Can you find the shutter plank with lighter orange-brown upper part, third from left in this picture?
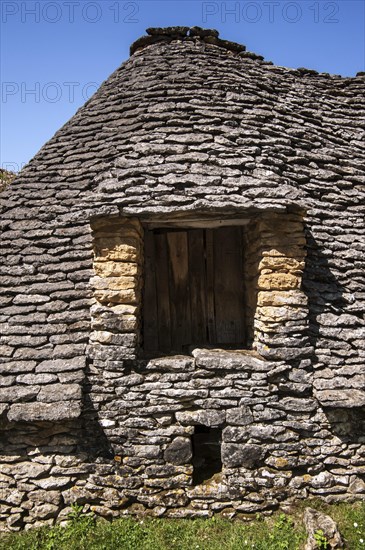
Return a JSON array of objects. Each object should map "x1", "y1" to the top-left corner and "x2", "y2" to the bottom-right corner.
[{"x1": 167, "y1": 231, "x2": 191, "y2": 352}]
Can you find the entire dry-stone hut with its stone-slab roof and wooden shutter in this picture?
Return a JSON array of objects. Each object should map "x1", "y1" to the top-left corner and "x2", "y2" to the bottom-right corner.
[{"x1": 0, "y1": 27, "x2": 365, "y2": 529}]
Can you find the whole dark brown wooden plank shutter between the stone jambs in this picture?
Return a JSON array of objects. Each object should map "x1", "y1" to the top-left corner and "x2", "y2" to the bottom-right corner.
[{"x1": 143, "y1": 226, "x2": 246, "y2": 354}]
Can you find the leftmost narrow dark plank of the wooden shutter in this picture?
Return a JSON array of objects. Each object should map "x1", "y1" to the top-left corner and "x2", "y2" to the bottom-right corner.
[{"x1": 143, "y1": 231, "x2": 158, "y2": 352}]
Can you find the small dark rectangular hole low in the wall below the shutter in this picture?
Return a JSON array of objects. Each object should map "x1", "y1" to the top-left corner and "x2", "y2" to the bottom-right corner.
[{"x1": 191, "y1": 425, "x2": 222, "y2": 485}]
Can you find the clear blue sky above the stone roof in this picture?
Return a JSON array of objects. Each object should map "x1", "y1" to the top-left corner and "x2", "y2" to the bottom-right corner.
[{"x1": 0, "y1": 0, "x2": 365, "y2": 171}]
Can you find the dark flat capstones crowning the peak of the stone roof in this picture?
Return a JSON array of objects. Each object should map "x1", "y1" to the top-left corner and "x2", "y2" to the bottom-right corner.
[{"x1": 130, "y1": 27, "x2": 250, "y2": 59}]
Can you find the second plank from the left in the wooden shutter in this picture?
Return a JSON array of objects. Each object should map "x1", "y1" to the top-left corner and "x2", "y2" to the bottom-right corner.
[{"x1": 155, "y1": 232, "x2": 171, "y2": 352}]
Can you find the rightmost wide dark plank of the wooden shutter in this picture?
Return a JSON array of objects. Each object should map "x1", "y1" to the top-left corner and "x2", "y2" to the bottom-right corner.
[{"x1": 214, "y1": 227, "x2": 244, "y2": 344}]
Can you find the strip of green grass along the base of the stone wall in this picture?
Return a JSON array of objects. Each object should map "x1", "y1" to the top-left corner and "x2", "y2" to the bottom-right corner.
[{"x1": 0, "y1": 501, "x2": 365, "y2": 550}]
